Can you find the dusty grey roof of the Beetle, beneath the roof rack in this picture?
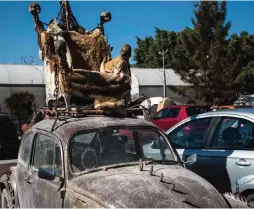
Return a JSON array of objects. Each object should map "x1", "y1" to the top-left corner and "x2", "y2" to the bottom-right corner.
[{"x1": 32, "y1": 116, "x2": 159, "y2": 143}]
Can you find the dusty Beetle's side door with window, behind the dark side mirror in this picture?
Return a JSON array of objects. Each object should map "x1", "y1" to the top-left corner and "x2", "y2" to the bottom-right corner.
[{"x1": 26, "y1": 131, "x2": 64, "y2": 208}]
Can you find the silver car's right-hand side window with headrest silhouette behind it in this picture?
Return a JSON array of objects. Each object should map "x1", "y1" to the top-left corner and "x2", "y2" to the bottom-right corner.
[{"x1": 210, "y1": 117, "x2": 254, "y2": 149}]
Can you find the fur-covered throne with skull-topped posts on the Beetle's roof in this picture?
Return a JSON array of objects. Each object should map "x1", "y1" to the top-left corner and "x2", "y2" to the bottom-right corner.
[{"x1": 29, "y1": 1, "x2": 131, "y2": 110}]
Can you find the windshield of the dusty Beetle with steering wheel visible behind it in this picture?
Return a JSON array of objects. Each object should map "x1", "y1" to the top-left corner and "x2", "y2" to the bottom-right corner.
[{"x1": 69, "y1": 127, "x2": 177, "y2": 174}]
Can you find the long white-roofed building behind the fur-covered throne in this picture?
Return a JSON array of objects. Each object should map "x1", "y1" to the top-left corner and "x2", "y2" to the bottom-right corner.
[{"x1": 0, "y1": 64, "x2": 194, "y2": 112}]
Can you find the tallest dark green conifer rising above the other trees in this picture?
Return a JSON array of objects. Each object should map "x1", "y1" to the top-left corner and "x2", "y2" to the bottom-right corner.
[{"x1": 172, "y1": 1, "x2": 234, "y2": 104}]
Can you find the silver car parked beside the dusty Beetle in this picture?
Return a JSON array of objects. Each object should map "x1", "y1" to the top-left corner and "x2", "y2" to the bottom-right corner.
[{"x1": 166, "y1": 108, "x2": 254, "y2": 207}]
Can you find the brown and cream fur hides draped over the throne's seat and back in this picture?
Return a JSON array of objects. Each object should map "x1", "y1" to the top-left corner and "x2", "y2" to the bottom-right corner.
[{"x1": 33, "y1": 14, "x2": 131, "y2": 109}]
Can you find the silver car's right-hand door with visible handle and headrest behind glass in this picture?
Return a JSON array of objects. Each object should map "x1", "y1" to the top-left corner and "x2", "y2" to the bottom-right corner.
[{"x1": 200, "y1": 116, "x2": 254, "y2": 193}]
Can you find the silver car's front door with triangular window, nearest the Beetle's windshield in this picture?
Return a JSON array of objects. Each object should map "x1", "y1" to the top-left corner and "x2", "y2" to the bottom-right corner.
[{"x1": 168, "y1": 116, "x2": 215, "y2": 175}]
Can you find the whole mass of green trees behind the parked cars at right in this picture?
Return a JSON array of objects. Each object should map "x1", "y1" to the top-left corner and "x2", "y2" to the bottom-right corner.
[{"x1": 134, "y1": 1, "x2": 254, "y2": 104}]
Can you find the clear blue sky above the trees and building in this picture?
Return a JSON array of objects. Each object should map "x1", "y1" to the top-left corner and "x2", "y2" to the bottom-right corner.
[{"x1": 0, "y1": 1, "x2": 254, "y2": 64}]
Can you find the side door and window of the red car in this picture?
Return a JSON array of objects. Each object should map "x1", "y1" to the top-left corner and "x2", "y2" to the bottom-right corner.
[{"x1": 153, "y1": 107, "x2": 180, "y2": 131}]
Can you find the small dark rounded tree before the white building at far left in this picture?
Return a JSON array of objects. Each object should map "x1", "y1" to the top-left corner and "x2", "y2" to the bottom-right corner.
[{"x1": 4, "y1": 91, "x2": 35, "y2": 127}]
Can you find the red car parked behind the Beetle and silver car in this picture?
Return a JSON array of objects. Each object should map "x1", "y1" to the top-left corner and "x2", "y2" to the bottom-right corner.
[{"x1": 152, "y1": 105, "x2": 211, "y2": 131}]
